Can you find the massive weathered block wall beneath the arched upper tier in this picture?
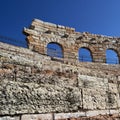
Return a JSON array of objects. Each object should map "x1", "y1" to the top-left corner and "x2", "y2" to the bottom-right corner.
[{"x1": 0, "y1": 43, "x2": 120, "y2": 120}]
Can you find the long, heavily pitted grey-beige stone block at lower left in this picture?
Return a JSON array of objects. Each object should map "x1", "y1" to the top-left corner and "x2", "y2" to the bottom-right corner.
[{"x1": 0, "y1": 80, "x2": 81, "y2": 115}]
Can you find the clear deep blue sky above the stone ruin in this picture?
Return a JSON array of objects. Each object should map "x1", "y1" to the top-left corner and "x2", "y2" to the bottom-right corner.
[{"x1": 0, "y1": 0, "x2": 120, "y2": 40}]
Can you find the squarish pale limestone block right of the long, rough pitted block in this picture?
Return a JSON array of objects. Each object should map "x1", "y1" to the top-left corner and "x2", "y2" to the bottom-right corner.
[{"x1": 82, "y1": 88, "x2": 106, "y2": 110}]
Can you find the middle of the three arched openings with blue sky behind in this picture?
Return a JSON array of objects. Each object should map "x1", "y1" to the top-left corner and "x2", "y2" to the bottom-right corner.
[{"x1": 78, "y1": 47, "x2": 93, "y2": 62}]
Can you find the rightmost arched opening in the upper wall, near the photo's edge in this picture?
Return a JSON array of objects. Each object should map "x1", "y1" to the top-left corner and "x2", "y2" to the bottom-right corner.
[{"x1": 106, "y1": 49, "x2": 119, "y2": 64}]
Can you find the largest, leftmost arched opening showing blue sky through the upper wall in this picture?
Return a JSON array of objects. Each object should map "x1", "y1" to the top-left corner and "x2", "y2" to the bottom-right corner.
[{"x1": 47, "y1": 42, "x2": 63, "y2": 58}]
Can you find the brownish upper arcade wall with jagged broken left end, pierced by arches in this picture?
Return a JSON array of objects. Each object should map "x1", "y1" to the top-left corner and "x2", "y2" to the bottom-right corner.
[{"x1": 24, "y1": 19, "x2": 120, "y2": 63}]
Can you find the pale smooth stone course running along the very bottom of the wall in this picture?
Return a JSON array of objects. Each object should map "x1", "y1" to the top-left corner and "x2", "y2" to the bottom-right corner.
[{"x1": 0, "y1": 110, "x2": 120, "y2": 120}]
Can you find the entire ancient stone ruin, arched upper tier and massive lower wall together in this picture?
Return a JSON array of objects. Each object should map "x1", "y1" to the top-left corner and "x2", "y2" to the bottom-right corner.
[{"x1": 0, "y1": 19, "x2": 120, "y2": 120}]
